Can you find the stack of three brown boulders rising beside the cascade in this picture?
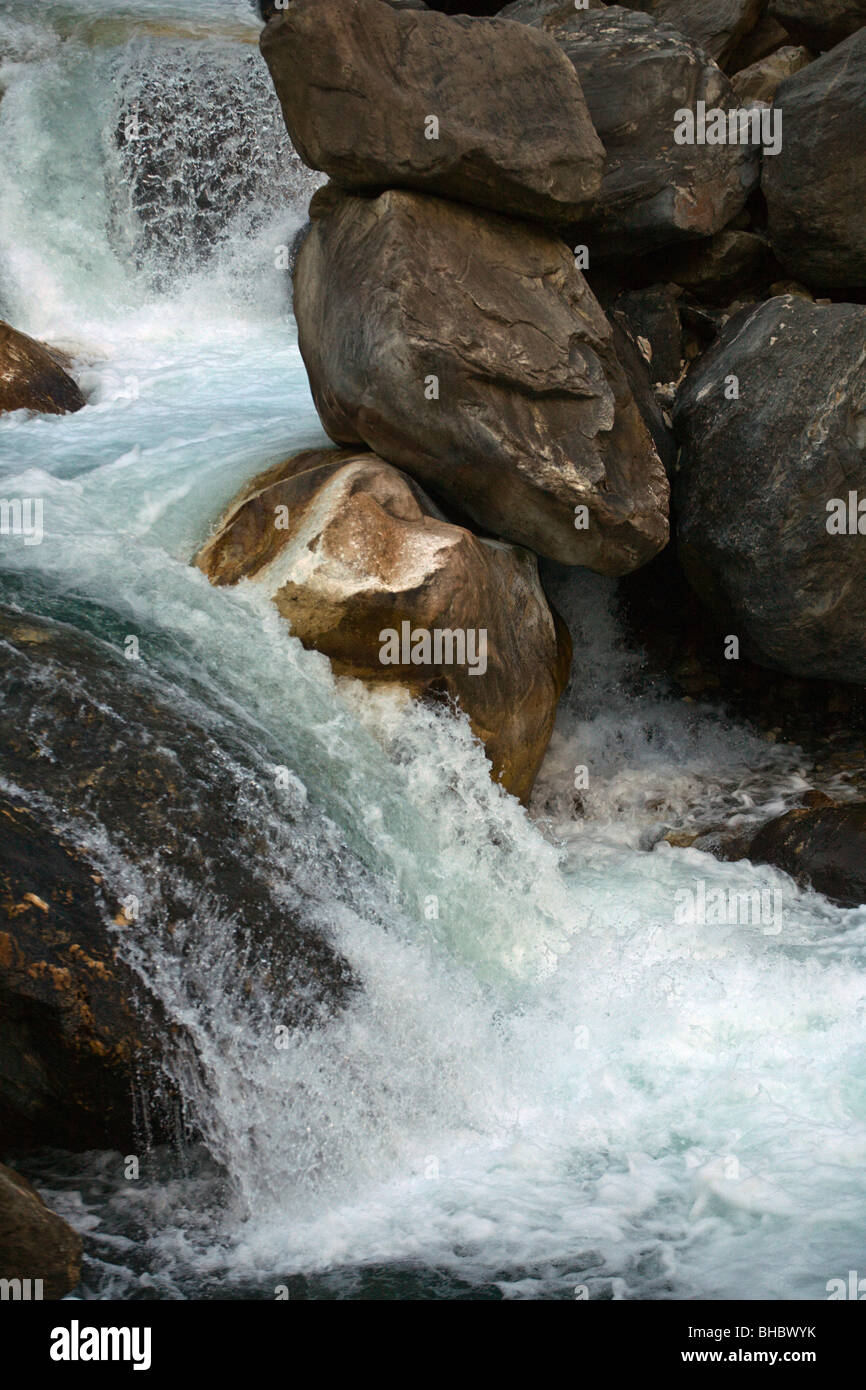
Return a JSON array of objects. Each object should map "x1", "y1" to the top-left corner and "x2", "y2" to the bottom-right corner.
[{"x1": 199, "y1": 0, "x2": 675, "y2": 799}]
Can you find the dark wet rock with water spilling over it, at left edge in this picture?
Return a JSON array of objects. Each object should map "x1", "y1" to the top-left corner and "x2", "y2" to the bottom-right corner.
[{"x1": 0, "y1": 609, "x2": 352, "y2": 1152}]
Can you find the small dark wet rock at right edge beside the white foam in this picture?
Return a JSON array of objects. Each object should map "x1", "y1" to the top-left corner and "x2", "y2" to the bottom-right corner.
[{"x1": 724, "y1": 802, "x2": 866, "y2": 908}]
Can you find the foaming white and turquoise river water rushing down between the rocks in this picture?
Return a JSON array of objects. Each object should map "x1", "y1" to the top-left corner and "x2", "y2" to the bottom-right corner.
[{"x1": 0, "y1": 0, "x2": 866, "y2": 1300}]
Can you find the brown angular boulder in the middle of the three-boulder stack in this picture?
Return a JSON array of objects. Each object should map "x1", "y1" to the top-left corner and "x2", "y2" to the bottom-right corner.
[{"x1": 295, "y1": 189, "x2": 667, "y2": 574}]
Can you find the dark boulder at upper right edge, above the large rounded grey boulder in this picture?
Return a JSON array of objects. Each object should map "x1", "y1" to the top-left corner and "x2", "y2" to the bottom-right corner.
[{"x1": 762, "y1": 29, "x2": 866, "y2": 288}]
